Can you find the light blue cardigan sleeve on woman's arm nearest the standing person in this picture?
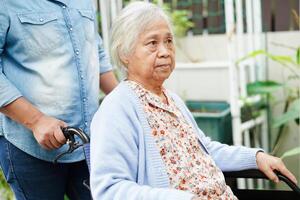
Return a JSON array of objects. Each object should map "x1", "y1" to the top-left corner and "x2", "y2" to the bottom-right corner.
[{"x1": 90, "y1": 86, "x2": 193, "y2": 200}]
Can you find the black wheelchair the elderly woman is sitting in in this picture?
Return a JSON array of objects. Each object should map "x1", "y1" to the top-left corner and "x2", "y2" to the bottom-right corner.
[{"x1": 54, "y1": 127, "x2": 300, "y2": 200}]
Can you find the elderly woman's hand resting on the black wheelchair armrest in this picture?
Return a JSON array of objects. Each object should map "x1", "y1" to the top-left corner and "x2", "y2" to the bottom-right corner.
[{"x1": 256, "y1": 152, "x2": 297, "y2": 184}]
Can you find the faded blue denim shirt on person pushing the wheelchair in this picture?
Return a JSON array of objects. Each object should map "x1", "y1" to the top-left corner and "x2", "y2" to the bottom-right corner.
[{"x1": 0, "y1": 0, "x2": 112, "y2": 162}]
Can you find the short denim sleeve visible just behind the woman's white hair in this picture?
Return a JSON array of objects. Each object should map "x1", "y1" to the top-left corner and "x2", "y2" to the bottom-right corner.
[{"x1": 97, "y1": 34, "x2": 112, "y2": 74}]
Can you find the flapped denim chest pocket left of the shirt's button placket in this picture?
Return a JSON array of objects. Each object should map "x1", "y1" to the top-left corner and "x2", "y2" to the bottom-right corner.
[{"x1": 18, "y1": 13, "x2": 63, "y2": 55}]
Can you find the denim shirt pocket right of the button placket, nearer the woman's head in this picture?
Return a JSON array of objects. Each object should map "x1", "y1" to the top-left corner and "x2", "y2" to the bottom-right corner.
[{"x1": 78, "y1": 10, "x2": 96, "y2": 42}]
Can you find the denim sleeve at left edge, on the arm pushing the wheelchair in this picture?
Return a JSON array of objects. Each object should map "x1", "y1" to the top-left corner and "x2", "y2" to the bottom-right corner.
[{"x1": 0, "y1": 0, "x2": 22, "y2": 107}]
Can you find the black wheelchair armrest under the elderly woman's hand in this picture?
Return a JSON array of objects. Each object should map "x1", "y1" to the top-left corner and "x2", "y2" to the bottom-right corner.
[{"x1": 223, "y1": 169, "x2": 300, "y2": 195}]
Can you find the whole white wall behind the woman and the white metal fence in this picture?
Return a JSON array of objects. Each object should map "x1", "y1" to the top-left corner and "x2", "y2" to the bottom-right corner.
[{"x1": 166, "y1": 31, "x2": 300, "y2": 101}]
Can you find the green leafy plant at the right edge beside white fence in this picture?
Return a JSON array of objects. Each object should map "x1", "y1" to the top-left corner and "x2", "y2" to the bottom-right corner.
[{"x1": 237, "y1": 44, "x2": 300, "y2": 158}]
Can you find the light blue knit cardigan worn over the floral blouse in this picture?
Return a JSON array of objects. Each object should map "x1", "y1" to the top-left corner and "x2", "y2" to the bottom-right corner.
[{"x1": 90, "y1": 82, "x2": 258, "y2": 200}]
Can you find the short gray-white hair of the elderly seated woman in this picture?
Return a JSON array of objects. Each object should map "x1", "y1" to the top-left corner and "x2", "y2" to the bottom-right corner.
[{"x1": 110, "y1": 2, "x2": 173, "y2": 68}]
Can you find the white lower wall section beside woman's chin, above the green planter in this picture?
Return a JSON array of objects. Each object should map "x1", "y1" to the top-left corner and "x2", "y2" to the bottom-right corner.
[{"x1": 166, "y1": 62, "x2": 229, "y2": 101}]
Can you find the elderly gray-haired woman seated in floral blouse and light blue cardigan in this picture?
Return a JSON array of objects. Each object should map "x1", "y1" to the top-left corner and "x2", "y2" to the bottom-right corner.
[{"x1": 91, "y1": 2, "x2": 296, "y2": 200}]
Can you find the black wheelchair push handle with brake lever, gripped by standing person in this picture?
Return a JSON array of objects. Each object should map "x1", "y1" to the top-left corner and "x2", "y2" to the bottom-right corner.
[{"x1": 53, "y1": 127, "x2": 90, "y2": 163}]
